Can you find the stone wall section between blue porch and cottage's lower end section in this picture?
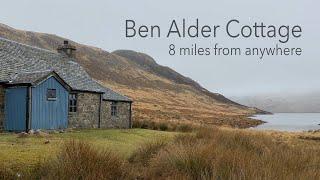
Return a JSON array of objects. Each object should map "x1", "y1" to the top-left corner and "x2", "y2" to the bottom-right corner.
[{"x1": 68, "y1": 92, "x2": 100, "y2": 128}]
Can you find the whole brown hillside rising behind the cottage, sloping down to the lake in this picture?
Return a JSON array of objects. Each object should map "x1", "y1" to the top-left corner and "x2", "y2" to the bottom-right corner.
[{"x1": 0, "y1": 24, "x2": 260, "y2": 127}]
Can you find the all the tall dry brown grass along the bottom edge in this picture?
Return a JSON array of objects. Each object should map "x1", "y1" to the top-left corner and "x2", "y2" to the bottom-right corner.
[{"x1": 0, "y1": 128, "x2": 320, "y2": 180}]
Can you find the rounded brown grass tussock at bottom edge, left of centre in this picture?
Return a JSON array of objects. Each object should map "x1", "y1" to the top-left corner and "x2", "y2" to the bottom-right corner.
[{"x1": 40, "y1": 141, "x2": 125, "y2": 179}]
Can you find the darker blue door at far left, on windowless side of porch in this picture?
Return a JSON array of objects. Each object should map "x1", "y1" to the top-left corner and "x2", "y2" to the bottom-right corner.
[{"x1": 5, "y1": 87, "x2": 27, "y2": 131}]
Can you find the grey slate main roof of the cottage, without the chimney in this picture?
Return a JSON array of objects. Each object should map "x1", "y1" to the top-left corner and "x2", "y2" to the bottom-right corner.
[{"x1": 0, "y1": 37, "x2": 131, "y2": 102}]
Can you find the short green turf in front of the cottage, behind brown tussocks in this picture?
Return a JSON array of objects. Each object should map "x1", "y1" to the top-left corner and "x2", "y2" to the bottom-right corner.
[{"x1": 0, "y1": 129, "x2": 175, "y2": 172}]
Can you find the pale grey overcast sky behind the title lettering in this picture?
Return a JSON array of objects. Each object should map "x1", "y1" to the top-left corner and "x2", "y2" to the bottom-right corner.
[{"x1": 0, "y1": 0, "x2": 320, "y2": 96}]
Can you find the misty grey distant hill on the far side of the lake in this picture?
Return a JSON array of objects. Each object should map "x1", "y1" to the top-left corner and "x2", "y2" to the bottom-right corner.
[{"x1": 231, "y1": 92, "x2": 320, "y2": 113}]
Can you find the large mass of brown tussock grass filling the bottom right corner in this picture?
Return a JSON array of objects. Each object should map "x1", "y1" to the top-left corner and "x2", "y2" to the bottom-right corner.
[{"x1": 138, "y1": 129, "x2": 320, "y2": 179}]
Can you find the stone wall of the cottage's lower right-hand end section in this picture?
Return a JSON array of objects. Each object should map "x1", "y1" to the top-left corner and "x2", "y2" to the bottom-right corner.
[{"x1": 101, "y1": 101, "x2": 131, "y2": 128}]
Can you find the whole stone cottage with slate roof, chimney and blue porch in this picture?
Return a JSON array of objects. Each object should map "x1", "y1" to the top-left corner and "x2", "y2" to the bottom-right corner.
[{"x1": 0, "y1": 38, "x2": 132, "y2": 131}]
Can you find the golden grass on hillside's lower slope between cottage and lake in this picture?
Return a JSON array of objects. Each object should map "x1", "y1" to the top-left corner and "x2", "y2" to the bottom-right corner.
[{"x1": 107, "y1": 85, "x2": 262, "y2": 128}]
